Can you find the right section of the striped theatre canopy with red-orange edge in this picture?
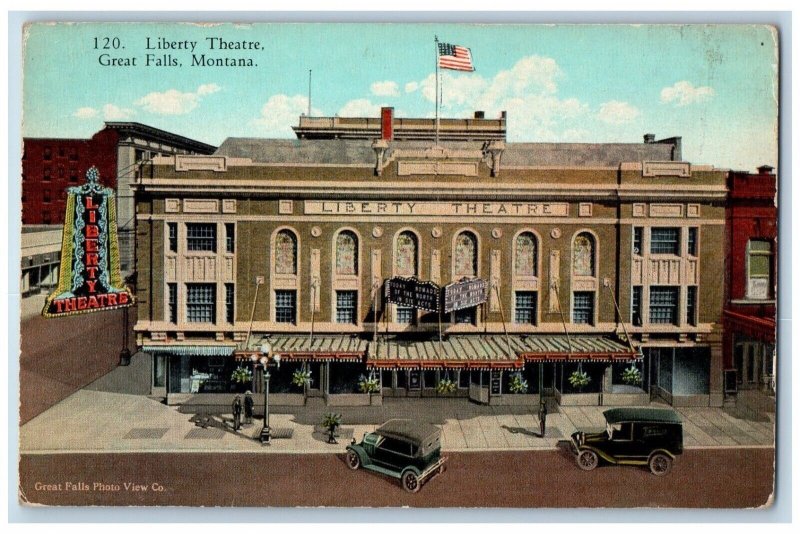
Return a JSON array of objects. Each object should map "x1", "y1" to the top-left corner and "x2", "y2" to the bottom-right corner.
[{"x1": 511, "y1": 335, "x2": 640, "y2": 362}]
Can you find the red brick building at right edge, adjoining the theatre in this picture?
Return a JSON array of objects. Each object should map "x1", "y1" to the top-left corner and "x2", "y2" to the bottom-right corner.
[{"x1": 724, "y1": 165, "x2": 778, "y2": 393}]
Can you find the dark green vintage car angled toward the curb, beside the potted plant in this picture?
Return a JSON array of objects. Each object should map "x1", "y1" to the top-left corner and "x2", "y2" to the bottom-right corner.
[{"x1": 347, "y1": 419, "x2": 447, "y2": 493}]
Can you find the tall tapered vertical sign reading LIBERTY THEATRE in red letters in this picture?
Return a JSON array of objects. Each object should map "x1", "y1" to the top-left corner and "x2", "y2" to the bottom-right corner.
[{"x1": 42, "y1": 167, "x2": 134, "y2": 317}]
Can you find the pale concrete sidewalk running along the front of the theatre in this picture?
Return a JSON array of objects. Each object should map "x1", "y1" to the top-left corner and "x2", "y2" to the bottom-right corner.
[{"x1": 20, "y1": 355, "x2": 775, "y2": 454}]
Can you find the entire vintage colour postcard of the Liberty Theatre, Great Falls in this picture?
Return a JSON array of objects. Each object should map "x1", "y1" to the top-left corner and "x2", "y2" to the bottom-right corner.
[{"x1": 17, "y1": 22, "x2": 781, "y2": 509}]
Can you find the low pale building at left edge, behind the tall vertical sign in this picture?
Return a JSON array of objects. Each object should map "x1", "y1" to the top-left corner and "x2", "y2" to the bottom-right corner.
[{"x1": 19, "y1": 225, "x2": 62, "y2": 319}]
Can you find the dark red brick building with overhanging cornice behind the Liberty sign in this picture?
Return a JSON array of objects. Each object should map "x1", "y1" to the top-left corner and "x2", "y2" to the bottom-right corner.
[{"x1": 22, "y1": 122, "x2": 215, "y2": 273}]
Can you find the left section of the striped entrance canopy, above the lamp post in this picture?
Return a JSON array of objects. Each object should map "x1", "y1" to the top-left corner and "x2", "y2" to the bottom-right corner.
[{"x1": 234, "y1": 334, "x2": 369, "y2": 362}]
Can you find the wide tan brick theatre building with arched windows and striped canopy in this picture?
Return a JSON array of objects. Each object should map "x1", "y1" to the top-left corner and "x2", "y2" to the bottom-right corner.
[{"x1": 134, "y1": 114, "x2": 726, "y2": 406}]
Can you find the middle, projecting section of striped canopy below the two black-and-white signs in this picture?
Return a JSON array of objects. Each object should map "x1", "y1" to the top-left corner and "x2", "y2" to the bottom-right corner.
[{"x1": 367, "y1": 335, "x2": 524, "y2": 369}]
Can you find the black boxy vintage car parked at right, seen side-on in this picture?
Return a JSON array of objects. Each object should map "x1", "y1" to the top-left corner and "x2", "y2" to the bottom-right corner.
[{"x1": 572, "y1": 408, "x2": 683, "y2": 476}]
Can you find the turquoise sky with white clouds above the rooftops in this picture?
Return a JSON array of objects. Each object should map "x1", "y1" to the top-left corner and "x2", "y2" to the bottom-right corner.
[{"x1": 23, "y1": 23, "x2": 778, "y2": 171}]
